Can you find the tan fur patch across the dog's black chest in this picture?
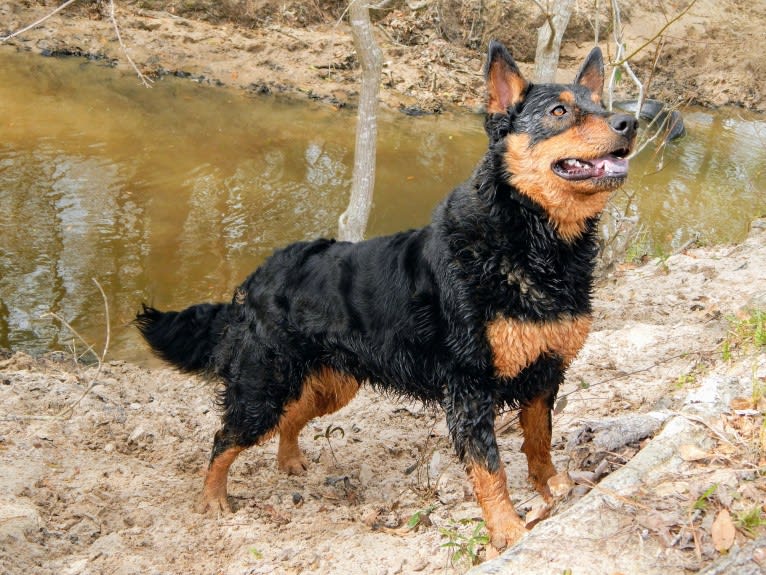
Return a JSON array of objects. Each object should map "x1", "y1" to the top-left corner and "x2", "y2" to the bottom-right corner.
[{"x1": 487, "y1": 316, "x2": 592, "y2": 377}]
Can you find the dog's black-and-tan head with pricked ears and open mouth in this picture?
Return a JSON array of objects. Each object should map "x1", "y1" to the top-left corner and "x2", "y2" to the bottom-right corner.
[{"x1": 485, "y1": 41, "x2": 638, "y2": 240}]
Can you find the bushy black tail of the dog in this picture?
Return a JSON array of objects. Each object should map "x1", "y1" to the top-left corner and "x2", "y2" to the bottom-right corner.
[{"x1": 133, "y1": 303, "x2": 231, "y2": 373}]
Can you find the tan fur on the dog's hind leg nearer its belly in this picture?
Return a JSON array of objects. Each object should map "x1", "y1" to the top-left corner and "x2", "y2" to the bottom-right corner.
[{"x1": 277, "y1": 367, "x2": 359, "y2": 475}]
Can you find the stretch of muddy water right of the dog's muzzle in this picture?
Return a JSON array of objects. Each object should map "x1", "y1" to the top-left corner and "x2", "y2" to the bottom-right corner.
[{"x1": 627, "y1": 111, "x2": 766, "y2": 253}]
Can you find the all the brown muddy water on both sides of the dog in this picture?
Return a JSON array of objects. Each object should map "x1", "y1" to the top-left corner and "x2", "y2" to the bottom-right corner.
[{"x1": 0, "y1": 50, "x2": 766, "y2": 361}]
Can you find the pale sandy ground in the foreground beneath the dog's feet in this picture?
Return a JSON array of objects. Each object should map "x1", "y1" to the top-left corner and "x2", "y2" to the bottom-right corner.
[{"x1": 0, "y1": 220, "x2": 766, "y2": 574}]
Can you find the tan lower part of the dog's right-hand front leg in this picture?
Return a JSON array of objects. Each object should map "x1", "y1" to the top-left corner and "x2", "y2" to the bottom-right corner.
[{"x1": 519, "y1": 397, "x2": 556, "y2": 501}]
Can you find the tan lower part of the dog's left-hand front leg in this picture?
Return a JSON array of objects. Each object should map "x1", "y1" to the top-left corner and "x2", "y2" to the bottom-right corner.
[{"x1": 468, "y1": 464, "x2": 526, "y2": 550}]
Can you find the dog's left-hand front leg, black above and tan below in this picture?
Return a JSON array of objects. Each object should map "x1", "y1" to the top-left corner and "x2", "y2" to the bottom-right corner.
[{"x1": 445, "y1": 385, "x2": 526, "y2": 551}]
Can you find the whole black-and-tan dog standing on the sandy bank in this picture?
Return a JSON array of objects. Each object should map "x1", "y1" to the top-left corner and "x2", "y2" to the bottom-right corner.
[{"x1": 135, "y1": 41, "x2": 638, "y2": 550}]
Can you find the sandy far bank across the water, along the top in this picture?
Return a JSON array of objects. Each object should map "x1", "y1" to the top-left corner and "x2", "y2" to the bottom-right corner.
[{"x1": 0, "y1": 0, "x2": 766, "y2": 112}]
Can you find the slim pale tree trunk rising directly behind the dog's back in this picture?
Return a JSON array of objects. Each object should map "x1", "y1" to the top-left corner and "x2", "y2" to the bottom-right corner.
[{"x1": 338, "y1": 0, "x2": 383, "y2": 242}]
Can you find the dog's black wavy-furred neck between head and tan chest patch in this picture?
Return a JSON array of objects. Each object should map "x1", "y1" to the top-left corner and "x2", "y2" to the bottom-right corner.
[{"x1": 432, "y1": 158, "x2": 598, "y2": 319}]
